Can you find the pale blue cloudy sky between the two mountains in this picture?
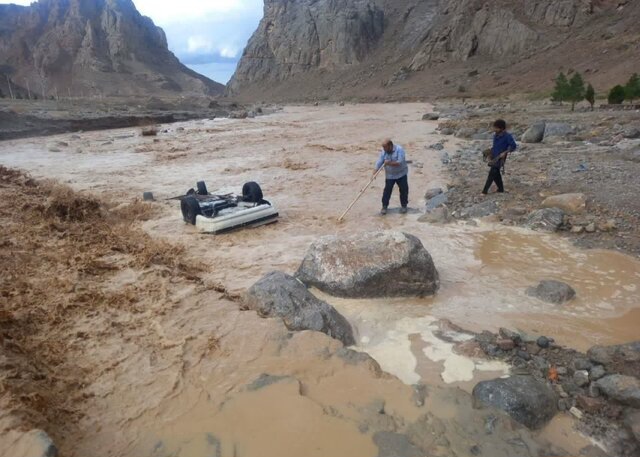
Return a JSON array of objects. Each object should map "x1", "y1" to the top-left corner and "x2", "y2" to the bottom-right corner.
[{"x1": 0, "y1": 0, "x2": 263, "y2": 83}]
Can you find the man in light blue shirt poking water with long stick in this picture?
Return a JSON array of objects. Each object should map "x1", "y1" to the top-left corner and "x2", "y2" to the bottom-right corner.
[{"x1": 374, "y1": 140, "x2": 409, "y2": 216}]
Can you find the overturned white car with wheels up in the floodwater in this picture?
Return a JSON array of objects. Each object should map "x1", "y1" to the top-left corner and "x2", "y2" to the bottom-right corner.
[{"x1": 180, "y1": 181, "x2": 279, "y2": 234}]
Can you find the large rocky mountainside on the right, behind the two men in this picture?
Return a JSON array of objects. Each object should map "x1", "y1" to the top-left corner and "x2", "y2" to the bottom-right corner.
[{"x1": 228, "y1": 0, "x2": 640, "y2": 97}]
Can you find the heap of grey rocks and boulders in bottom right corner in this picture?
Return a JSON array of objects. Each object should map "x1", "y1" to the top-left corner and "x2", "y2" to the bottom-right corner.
[{"x1": 450, "y1": 324, "x2": 640, "y2": 457}]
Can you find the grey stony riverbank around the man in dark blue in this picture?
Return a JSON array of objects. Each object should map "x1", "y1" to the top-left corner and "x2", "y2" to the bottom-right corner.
[{"x1": 425, "y1": 102, "x2": 640, "y2": 255}]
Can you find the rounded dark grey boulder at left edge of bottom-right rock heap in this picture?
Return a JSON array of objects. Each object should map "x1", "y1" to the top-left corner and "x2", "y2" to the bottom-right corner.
[{"x1": 473, "y1": 376, "x2": 558, "y2": 429}]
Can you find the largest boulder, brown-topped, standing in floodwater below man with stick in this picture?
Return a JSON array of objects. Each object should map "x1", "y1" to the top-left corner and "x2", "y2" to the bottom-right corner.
[{"x1": 297, "y1": 231, "x2": 440, "y2": 298}]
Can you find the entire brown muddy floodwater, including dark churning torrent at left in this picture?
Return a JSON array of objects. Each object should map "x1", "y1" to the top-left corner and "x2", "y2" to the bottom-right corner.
[{"x1": 0, "y1": 104, "x2": 640, "y2": 456}]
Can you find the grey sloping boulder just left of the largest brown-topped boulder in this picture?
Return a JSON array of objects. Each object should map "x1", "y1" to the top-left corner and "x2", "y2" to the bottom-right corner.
[{"x1": 244, "y1": 271, "x2": 355, "y2": 346}]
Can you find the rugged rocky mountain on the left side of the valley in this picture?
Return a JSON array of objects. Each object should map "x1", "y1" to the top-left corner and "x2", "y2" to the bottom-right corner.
[{"x1": 0, "y1": 0, "x2": 223, "y2": 96}]
